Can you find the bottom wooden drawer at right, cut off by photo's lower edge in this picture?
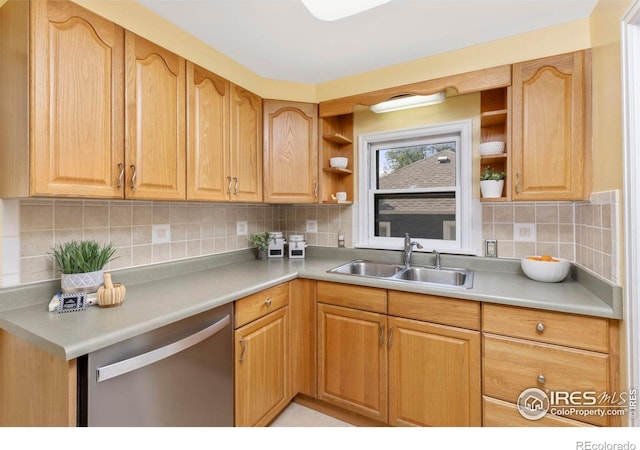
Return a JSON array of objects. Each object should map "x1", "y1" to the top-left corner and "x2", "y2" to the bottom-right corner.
[{"x1": 482, "y1": 397, "x2": 591, "y2": 427}]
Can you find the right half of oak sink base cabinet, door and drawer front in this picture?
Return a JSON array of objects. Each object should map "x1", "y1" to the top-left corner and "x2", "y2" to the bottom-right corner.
[{"x1": 387, "y1": 290, "x2": 482, "y2": 427}]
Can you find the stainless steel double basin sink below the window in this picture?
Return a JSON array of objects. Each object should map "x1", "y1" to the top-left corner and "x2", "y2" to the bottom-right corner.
[{"x1": 328, "y1": 259, "x2": 473, "y2": 289}]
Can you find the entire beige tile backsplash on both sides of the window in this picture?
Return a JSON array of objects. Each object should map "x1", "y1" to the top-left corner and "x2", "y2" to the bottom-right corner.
[{"x1": 0, "y1": 191, "x2": 621, "y2": 287}]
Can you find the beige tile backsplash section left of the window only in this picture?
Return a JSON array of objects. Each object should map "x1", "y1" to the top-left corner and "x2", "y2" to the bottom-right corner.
[{"x1": 11, "y1": 199, "x2": 351, "y2": 287}]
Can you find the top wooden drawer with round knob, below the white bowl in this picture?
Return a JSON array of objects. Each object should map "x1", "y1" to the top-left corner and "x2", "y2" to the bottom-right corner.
[{"x1": 482, "y1": 304, "x2": 609, "y2": 353}]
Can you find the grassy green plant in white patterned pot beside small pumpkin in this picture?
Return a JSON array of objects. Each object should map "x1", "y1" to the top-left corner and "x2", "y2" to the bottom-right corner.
[{"x1": 51, "y1": 241, "x2": 116, "y2": 293}]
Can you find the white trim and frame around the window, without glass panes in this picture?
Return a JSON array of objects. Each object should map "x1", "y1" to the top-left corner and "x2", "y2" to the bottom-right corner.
[{"x1": 355, "y1": 119, "x2": 482, "y2": 255}]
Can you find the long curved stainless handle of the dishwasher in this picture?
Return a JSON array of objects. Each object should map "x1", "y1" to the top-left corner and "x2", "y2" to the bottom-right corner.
[{"x1": 96, "y1": 314, "x2": 231, "y2": 383}]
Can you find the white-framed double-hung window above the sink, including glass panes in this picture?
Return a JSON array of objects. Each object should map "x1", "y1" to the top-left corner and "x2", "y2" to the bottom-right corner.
[{"x1": 358, "y1": 120, "x2": 480, "y2": 254}]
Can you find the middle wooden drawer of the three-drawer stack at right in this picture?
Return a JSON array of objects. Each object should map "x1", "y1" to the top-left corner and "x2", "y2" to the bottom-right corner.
[{"x1": 482, "y1": 335, "x2": 610, "y2": 425}]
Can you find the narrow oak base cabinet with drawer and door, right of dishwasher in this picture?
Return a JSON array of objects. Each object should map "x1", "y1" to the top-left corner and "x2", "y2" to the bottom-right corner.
[{"x1": 234, "y1": 283, "x2": 292, "y2": 427}]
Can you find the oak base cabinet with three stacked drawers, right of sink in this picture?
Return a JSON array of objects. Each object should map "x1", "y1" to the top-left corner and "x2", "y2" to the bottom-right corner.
[{"x1": 482, "y1": 304, "x2": 620, "y2": 426}]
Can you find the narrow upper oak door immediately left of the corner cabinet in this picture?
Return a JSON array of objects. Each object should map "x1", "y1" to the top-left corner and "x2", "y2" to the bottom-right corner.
[{"x1": 229, "y1": 84, "x2": 262, "y2": 202}]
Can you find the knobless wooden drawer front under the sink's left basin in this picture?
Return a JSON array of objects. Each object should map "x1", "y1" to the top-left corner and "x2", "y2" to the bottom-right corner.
[{"x1": 318, "y1": 281, "x2": 387, "y2": 314}]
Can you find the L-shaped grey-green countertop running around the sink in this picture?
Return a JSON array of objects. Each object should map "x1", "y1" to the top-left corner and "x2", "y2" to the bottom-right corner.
[{"x1": 0, "y1": 248, "x2": 622, "y2": 360}]
